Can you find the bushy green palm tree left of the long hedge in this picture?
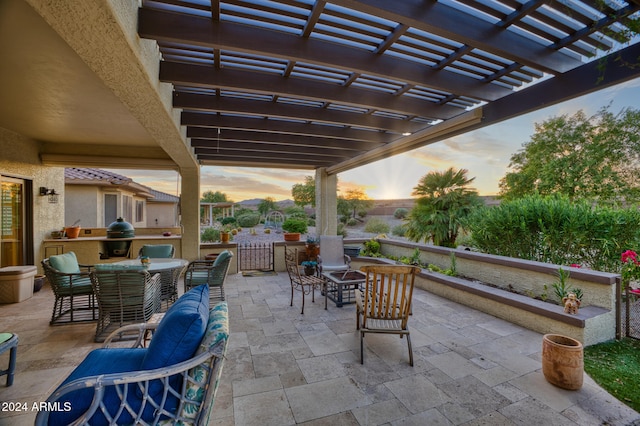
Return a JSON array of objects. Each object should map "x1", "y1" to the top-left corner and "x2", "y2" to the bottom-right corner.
[{"x1": 405, "y1": 168, "x2": 482, "y2": 247}]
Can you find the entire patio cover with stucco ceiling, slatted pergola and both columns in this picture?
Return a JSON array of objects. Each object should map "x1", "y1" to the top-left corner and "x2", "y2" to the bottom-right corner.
[{"x1": 0, "y1": 0, "x2": 640, "y2": 256}]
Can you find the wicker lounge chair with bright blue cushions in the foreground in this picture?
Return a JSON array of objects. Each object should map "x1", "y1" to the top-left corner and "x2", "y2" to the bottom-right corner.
[{"x1": 35, "y1": 286, "x2": 229, "y2": 426}]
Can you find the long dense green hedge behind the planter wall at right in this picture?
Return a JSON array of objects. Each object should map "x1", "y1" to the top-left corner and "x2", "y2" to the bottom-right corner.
[{"x1": 467, "y1": 196, "x2": 640, "y2": 273}]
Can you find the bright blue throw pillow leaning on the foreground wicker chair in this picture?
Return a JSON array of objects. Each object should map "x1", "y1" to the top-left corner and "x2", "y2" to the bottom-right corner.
[{"x1": 142, "y1": 284, "x2": 209, "y2": 370}]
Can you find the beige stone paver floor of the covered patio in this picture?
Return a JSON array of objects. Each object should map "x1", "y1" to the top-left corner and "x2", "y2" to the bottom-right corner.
[{"x1": 0, "y1": 274, "x2": 640, "y2": 426}]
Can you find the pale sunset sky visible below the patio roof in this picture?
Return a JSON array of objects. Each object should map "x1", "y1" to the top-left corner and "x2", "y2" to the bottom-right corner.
[{"x1": 110, "y1": 79, "x2": 640, "y2": 202}]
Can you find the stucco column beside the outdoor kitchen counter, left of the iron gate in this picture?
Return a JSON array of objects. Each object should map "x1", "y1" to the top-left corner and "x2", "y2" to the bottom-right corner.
[{"x1": 180, "y1": 168, "x2": 200, "y2": 260}]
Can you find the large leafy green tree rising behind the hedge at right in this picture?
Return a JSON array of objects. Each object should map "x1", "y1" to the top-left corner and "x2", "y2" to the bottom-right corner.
[{"x1": 500, "y1": 107, "x2": 640, "y2": 203}]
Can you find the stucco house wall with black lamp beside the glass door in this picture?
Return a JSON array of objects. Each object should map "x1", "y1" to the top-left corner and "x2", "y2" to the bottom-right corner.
[{"x1": 0, "y1": 128, "x2": 64, "y2": 266}]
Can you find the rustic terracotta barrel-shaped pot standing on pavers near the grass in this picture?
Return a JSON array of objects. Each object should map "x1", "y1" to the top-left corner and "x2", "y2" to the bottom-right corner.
[{"x1": 542, "y1": 334, "x2": 584, "y2": 390}]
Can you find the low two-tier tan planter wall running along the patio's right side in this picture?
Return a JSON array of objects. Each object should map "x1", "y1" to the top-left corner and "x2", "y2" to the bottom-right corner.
[{"x1": 362, "y1": 239, "x2": 619, "y2": 346}]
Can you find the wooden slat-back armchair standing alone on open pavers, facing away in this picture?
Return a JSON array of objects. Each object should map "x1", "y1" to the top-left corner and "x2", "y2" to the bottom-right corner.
[{"x1": 356, "y1": 265, "x2": 420, "y2": 366}]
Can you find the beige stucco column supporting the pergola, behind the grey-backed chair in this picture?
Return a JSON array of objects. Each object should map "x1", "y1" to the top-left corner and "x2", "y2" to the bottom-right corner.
[{"x1": 316, "y1": 168, "x2": 338, "y2": 235}]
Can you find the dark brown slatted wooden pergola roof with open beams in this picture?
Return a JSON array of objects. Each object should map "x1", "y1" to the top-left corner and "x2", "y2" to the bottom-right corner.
[{"x1": 138, "y1": 0, "x2": 640, "y2": 173}]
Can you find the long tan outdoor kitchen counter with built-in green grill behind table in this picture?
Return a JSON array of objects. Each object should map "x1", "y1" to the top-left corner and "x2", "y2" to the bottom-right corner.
[{"x1": 41, "y1": 234, "x2": 182, "y2": 265}]
